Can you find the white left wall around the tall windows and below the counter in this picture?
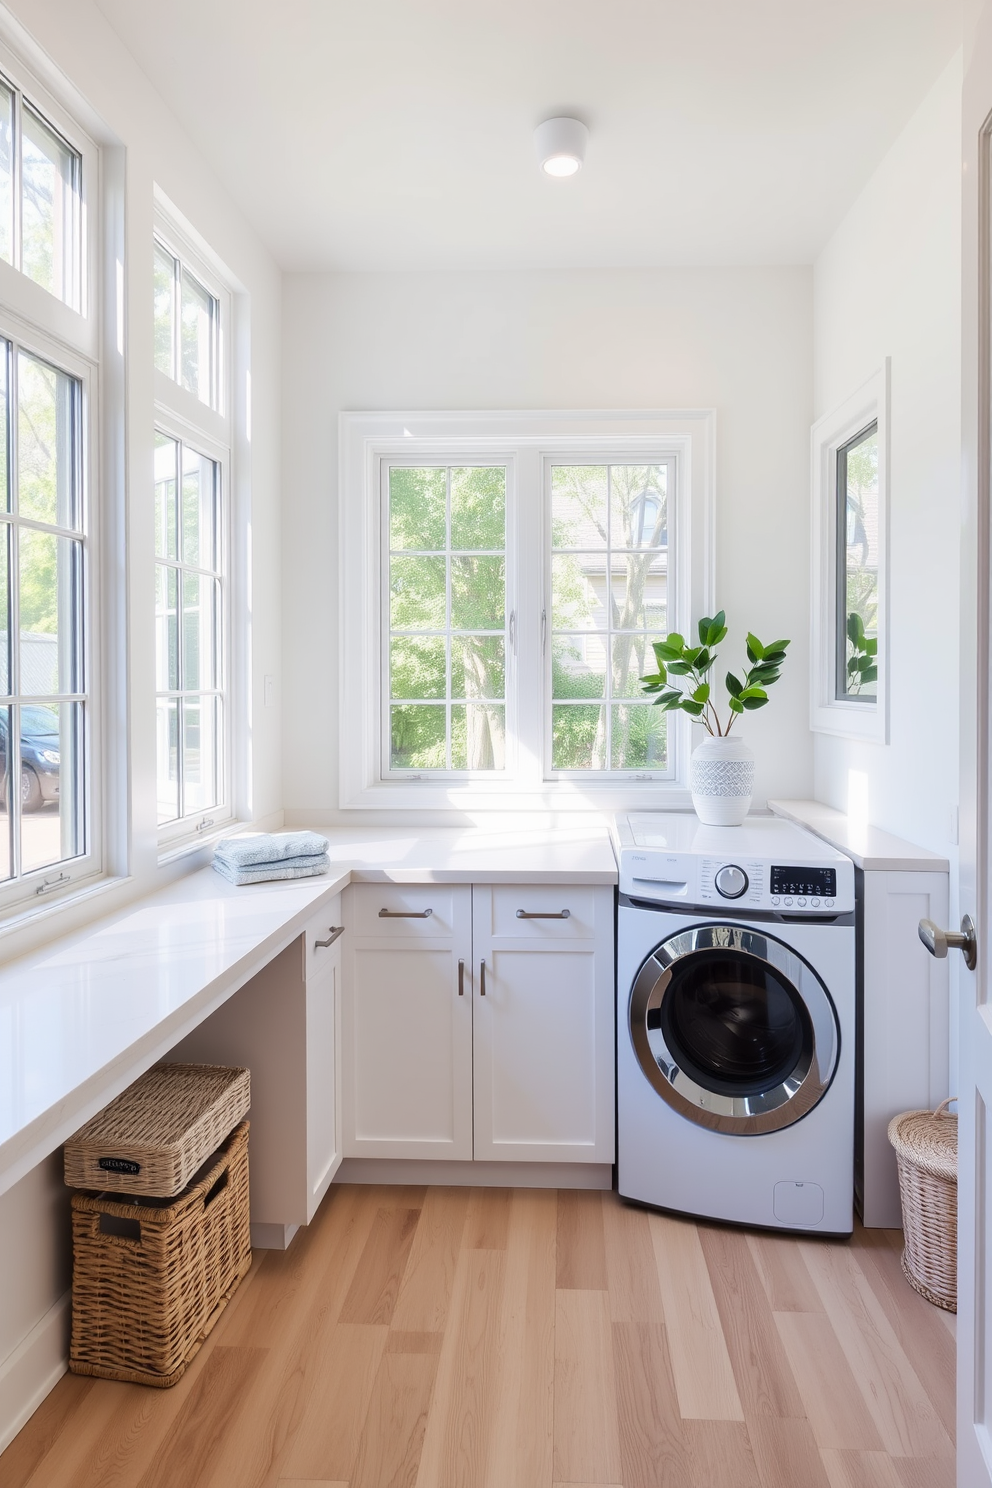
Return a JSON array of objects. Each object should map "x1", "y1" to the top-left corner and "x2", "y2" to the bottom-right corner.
[{"x1": 0, "y1": 0, "x2": 281, "y2": 1446}]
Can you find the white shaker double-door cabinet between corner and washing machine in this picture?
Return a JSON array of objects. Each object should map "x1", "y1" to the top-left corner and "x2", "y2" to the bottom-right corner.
[{"x1": 344, "y1": 884, "x2": 614, "y2": 1164}]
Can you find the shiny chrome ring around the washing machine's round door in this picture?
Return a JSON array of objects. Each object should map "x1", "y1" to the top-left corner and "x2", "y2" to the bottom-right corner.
[{"x1": 628, "y1": 924, "x2": 840, "y2": 1137}]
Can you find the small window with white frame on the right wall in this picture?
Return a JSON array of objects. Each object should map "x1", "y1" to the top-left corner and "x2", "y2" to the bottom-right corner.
[{"x1": 811, "y1": 365, "x2": 888, "y2": 743}]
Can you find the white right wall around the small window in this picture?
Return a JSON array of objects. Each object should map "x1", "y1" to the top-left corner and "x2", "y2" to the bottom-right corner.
[{"x1": 814, "y1": 57, "x2": 961, "y2": 857}]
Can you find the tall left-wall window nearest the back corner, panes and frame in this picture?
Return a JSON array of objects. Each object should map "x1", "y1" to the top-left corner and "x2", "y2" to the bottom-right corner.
[{"x1": 153, "y1": 222, "x2": 233, "y2": 850}]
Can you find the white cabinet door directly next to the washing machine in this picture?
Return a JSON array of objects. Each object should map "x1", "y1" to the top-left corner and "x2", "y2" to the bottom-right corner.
[{"x1": 473, "y1": 885, "x2": 614, "y2": 1162}]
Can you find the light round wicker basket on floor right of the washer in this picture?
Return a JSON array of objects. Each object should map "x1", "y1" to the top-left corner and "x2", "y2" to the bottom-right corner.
[{"x1": 889, "y1": 1097, "x2": 958, "y2": 1312}]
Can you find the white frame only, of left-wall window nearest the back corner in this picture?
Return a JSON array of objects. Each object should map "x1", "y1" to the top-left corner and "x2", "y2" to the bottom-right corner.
[{"x1": 147, "y1": 200, "x2": 237, "y2": 862}]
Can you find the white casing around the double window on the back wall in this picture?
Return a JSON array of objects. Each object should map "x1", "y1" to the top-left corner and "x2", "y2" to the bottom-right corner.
[{"x1": 339, "y1": 409, "x2": 715, "y2": 811}]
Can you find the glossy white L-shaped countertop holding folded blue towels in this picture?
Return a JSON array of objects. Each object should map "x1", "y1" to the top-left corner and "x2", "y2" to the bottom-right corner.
[{"x1": 0, "y1": 824, "x2": 617, "y2": 1193}]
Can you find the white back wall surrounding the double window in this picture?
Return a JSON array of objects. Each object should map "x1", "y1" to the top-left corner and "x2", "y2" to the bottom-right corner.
[{"x1": 283, "y1": 268, "x2": 812, "y2": 824}]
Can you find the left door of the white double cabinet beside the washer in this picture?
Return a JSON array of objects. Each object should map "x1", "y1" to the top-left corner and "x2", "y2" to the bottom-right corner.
[{"x1": 342, "y1": 884, "x2": 471, "y2": 1159}]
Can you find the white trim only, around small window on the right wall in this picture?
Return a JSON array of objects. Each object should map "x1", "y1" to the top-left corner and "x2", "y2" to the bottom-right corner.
[{"x1": 809, "y1": 357, "x2": 889, "y2": 744}]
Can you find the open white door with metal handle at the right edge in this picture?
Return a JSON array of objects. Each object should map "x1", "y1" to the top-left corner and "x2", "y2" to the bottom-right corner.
[{"x1": 950, "y1": 17, "x2": 992, "y2": 1488}]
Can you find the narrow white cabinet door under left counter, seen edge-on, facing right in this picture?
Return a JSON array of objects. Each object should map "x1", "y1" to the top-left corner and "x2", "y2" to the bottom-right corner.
[{"x1": 306, "y1": 897, "x2": 342, "y2": 1220}]
